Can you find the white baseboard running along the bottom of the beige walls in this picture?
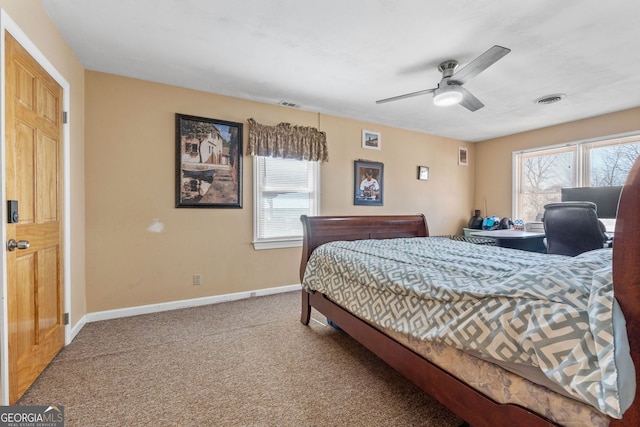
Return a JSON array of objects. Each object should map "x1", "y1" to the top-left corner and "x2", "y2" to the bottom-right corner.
[{"x1": 67, "y1": 284, "x2": 301, "y2": 344}]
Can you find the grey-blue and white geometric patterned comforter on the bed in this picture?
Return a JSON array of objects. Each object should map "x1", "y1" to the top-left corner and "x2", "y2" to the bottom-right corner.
[{"x1": 302, "y1": 237, "x2": 622, "y2": 418}]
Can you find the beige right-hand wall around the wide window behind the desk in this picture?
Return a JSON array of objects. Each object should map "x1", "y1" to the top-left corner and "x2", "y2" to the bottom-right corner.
[{"x1": 474, "y1": 108, "x2": 640, "y2": 221}]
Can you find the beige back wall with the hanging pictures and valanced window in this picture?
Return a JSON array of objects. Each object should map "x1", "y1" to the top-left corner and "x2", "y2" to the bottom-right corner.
[{"x1": 86, "y1": 72, "x2": 474, "y2": 312}]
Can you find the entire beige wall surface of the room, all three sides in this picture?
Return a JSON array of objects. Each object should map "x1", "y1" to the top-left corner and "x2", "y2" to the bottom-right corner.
[{"x1": 8, "y1": 0, "x2": 640, "y2": 318}]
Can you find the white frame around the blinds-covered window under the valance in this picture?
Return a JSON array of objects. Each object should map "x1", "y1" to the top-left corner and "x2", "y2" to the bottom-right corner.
[{"x1": 252, "y1": 156, "x2": 320, "y2": 250}]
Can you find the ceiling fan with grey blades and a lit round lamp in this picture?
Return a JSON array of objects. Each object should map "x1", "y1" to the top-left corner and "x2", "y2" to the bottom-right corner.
[{"x1": 376, "y1": 45, "x2": 511, "y2": 111}]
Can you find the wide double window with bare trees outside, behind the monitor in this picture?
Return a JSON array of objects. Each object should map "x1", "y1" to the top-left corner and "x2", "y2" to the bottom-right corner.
[{"x1": 514, "y1": 135, "x2": 640, "y2": 221}]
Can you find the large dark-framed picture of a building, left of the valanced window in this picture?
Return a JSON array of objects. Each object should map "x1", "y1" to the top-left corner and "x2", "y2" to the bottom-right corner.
[{"x1": 176, "y1": 113, "x2": 242, "y2": 208}]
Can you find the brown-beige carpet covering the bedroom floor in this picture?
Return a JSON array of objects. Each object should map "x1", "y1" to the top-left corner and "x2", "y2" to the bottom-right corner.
[{"x1": 19, "y1": 292, "x2": 461, "y2": 427}]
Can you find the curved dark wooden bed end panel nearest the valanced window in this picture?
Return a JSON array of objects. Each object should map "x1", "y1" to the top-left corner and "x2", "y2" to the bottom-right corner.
[{"x1": 300, "y1": 214, "x2": 429, "y2": 280}]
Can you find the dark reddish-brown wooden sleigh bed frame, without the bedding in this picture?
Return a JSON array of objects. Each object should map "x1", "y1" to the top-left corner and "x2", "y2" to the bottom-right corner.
[{"x1": 300, "y1": 159, "x2": 640, "y2": 427}]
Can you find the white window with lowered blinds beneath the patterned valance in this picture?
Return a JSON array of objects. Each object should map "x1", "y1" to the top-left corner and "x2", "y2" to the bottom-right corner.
[{"x1": 253, "y1": 156, "x2": 320, "y2": 249}]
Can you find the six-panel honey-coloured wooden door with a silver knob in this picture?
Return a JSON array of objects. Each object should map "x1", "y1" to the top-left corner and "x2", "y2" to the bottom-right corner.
[{"x1": 5, "y1": 33, "x2": 64, "y2": 404}]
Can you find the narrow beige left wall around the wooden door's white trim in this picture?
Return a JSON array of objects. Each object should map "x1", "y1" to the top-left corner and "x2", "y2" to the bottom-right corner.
[{"x1": 0, "y1": 0, "x2": 86, "y2": 325}]
